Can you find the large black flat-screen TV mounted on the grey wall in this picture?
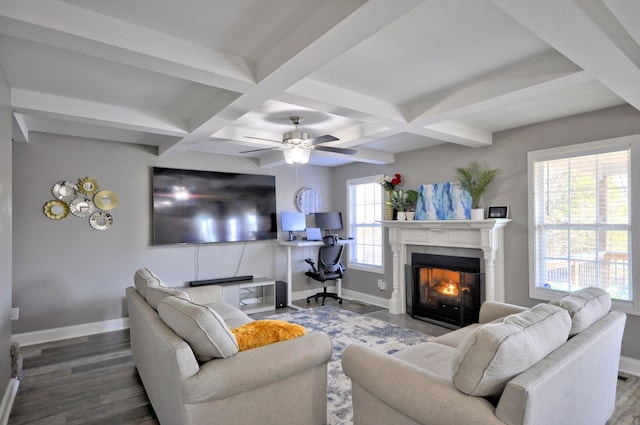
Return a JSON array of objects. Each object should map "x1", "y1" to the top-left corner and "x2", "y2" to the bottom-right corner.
[{"x1": 152, "y1": 167, "x2": 277, "y2": 245}]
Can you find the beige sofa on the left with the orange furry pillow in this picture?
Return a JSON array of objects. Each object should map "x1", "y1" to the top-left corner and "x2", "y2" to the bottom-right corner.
[{"x1": 126, "y1": 269, "x2": 332, "y2": 425}]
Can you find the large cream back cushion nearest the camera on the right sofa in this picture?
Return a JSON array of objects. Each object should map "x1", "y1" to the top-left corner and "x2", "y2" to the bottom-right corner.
[{"x1": 451, "y1": 304, "x2": 571, "y2": 397}]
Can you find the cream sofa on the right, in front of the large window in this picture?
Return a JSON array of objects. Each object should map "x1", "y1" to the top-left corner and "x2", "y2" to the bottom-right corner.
[{"x1": 342, "y1": 288, "x2": 626, "y2": 425}]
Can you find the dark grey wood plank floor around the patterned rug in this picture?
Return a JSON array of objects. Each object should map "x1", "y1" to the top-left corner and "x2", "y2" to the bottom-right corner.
[{"x1": 9, "y1": 300, "x2": 446, "y2": 425}]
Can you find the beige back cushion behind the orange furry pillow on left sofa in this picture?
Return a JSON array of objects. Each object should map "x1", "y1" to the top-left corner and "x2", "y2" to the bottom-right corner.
[{"x1": 158, "y1": 297, "x2": 238, "y2": 362}]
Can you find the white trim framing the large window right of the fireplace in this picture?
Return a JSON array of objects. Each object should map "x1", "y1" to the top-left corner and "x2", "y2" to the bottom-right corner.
[{"x1": 527, "y1": 135, "x2": 640, "y2": 315}]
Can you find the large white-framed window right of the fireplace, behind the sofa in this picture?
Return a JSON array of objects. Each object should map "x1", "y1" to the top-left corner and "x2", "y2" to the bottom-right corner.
[{"x1": 528, "y1": 136, "x2": 640, "y2": 311}]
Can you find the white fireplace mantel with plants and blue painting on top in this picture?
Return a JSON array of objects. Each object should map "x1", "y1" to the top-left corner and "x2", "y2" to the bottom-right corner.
[{"x1": 382, "y1": 219, "x2": 511, "y2": 314}]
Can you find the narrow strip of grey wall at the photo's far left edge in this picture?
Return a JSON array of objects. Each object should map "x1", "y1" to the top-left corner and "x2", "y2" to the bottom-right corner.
[{"x1": 0, "y1": 63, "x2": 11, "y2": 390}]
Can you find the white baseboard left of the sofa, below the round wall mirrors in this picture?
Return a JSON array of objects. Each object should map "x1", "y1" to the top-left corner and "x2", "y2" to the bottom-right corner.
[{"x1": 11, "y1": 317, "x2": 129, "y2": 346}]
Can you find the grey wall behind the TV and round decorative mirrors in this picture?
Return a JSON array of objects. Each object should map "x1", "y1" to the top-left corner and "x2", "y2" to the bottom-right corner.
[{"x1": 12, "y1": 133, "x2": 331, "y2": 333}]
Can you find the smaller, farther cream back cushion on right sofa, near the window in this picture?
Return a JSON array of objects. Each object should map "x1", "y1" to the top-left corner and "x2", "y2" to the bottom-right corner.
[{"x1": 551, "y1": 287, "x2": 611, "y2": 336}]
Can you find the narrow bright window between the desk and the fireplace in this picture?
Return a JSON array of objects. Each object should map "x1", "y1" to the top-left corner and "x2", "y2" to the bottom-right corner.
[{"x1": 347, "y1": 176, "x2": 384, "y2": 273}]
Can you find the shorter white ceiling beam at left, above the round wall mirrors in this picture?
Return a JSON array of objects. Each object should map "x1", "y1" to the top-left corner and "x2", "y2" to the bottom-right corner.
[{"x1": 11, "y1": 89, "x2": 187, "y2": 137}]
